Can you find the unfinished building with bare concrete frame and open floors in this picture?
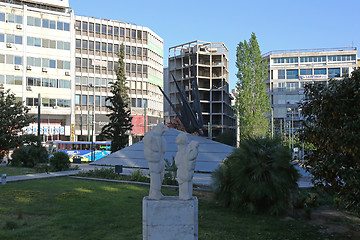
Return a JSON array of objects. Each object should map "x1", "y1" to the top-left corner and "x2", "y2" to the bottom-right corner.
[{"x1": 164, "y1": 41, "x2": 235, "y2": 138}]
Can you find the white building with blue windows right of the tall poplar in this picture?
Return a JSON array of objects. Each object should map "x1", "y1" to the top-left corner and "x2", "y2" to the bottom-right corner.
[{"x1": 263, "y1": 48, "x2": 357, "y2": 132}]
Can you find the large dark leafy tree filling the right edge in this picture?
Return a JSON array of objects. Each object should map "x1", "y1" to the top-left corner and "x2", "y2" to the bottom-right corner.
[{"x1": 300, "y1": 69, "x2": 360, "y2": 213}]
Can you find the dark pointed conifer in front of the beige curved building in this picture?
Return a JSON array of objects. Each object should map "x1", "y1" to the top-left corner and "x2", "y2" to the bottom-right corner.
[{"x1": 101, "y1": 45, "x2": 132, "y2": 152}]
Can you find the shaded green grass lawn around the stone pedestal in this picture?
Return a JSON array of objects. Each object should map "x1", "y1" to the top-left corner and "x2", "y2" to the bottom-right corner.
[{"x1": 0, "y1": 177, "x2": 354, "y2": 240}]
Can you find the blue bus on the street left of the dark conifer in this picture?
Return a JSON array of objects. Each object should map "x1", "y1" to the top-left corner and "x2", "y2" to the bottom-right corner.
[{"x1": 49, "y1": 141, "x2": 111, "y2": 162}]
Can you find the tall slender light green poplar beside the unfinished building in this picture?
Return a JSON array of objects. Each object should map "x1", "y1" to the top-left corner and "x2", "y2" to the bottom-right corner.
[{"x1": 235, "y1": 33, "x2": 270, "y2": 140}]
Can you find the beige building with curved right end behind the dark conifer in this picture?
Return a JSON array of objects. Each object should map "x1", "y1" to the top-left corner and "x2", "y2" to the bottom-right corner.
[{"x1": 74, "y1": 16, "x2": 163, "y2": 140}]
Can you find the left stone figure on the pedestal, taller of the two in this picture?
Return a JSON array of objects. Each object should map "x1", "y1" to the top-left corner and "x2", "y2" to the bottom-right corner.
[{"x1": 144, "y1": 123, "x2": 169, "y2": 200}]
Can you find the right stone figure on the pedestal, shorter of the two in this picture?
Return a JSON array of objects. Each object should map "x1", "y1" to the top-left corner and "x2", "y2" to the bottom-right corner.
[{"x1": 175, "y1": 133, "x2": 199, "y2": 200}]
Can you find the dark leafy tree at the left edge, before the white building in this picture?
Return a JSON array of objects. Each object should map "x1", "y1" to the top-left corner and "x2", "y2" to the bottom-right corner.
[{"x1": 0, "y1": 90, "x2": 34, "y2": 158}]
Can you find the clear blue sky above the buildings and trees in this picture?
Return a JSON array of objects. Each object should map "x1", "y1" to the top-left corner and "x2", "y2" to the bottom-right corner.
[{"x1": 69, "y1": 0, "x2": 360, "y2": 88}]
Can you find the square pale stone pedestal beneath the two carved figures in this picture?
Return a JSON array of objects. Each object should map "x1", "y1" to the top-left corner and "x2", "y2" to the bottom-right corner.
[{"x1": 143, "y1": 196, "x2": 198, "y2": 240}]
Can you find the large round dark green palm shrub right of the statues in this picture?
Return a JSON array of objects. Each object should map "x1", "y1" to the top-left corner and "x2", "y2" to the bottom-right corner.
[{"x1": 212, "y1": 137, "x2": 299, "y2": 215}]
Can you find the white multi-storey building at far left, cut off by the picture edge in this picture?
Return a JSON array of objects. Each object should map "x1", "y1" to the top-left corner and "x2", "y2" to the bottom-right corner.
[{"x1": 0, "y1": 0, "x2": 75, "y2": 140}]
